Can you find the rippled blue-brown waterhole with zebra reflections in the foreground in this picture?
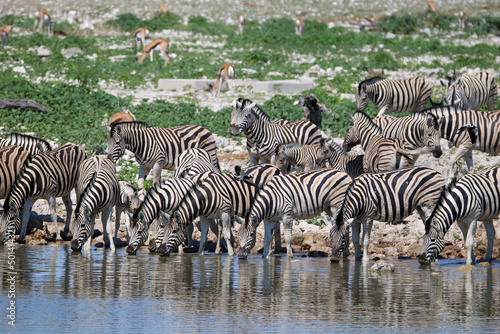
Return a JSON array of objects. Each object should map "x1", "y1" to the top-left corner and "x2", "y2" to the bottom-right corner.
[{"x1": 0, "y1": 245, "x2": 500, "y2": 333}]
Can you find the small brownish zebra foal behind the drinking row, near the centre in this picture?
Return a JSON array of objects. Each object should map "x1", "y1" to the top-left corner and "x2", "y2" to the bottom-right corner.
[{"x1": 274, "y1": 138, "x2": 326, "y2": 173}]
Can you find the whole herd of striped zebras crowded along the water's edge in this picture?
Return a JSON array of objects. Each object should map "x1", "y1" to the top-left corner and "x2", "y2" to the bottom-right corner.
[{"x1": 0, "y1": 72, "x2": 500, "y2": 264}]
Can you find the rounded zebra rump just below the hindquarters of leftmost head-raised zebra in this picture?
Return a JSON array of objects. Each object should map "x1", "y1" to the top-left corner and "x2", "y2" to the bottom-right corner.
[{"x1": 174, "y1": 148, "x2": 220, "y2": 178}]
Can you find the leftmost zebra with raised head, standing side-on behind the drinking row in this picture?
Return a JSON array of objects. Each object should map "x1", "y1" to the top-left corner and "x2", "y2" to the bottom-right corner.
[{"x1": 108, "y1": 122, "x2": 219, "y2": 190}]
